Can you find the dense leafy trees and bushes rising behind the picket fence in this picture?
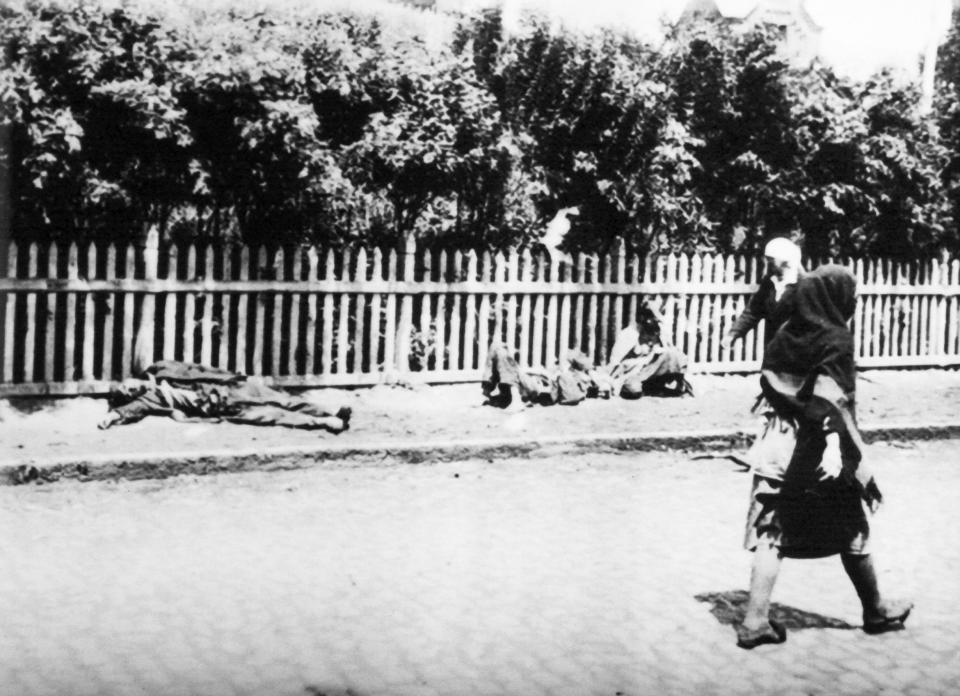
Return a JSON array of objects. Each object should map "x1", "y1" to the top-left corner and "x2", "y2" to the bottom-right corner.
[{"x1": 0, "y1": 2, "x2": 960, "y2": 258}]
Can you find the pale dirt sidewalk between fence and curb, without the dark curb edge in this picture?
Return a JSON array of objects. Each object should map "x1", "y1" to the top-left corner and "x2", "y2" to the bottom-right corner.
[{"x1": 0, "y1": 370, "x2": 960, "y2": 474}]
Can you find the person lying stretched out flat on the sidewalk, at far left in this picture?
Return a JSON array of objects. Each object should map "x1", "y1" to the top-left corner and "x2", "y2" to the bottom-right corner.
[{"x1": 98, "y1": 360, "x2": 352, "y2": 433}]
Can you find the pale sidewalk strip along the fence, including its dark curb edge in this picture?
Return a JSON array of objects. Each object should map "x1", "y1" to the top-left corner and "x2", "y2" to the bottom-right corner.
[{"x1": 0, "y1": 370, "x2": 960, "y2": 482}]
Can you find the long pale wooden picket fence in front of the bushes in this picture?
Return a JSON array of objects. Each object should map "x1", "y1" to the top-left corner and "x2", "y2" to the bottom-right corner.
[{"x1": 0, "y1": 236, "x2": 960, "y2": 394}]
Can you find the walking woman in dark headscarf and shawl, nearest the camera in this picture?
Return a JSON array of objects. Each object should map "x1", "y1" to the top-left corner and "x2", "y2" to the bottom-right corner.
[{"x1": 737, "y1": 265, "x2": 912, "y2": 649}]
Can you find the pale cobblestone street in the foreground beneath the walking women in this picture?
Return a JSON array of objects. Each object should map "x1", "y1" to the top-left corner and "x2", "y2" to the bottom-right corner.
[{"x1": 0, "y1": 442, "x2": 960, "y2": 696}]
